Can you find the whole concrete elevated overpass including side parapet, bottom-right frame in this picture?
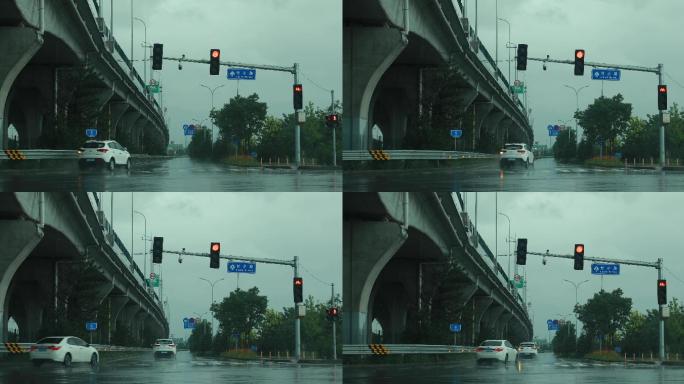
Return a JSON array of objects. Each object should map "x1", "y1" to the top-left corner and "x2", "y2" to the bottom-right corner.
[{"x1": 343, "y1": 193, "x2": 532, "y2": 345}]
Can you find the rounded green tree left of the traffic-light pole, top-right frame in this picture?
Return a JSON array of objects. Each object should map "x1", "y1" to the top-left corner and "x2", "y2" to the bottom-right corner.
[{"x1": 575, "y1": 94, "x2": 632, "y2": 156}]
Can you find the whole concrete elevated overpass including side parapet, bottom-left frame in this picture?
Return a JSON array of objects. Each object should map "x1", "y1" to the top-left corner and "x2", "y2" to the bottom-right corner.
[{"x1": 0, "y1": 193, "x2": 169, "y2": 344}]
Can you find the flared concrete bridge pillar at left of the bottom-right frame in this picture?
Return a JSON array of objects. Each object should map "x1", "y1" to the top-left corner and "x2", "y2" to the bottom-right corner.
[{"x1": 343, "y1": 220, "x2": 407, "y2": 344}]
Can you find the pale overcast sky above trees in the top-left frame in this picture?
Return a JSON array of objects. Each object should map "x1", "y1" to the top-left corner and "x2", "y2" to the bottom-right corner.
[{"x1": 102, "y1": 0, "x2": 342, "y2": 146}]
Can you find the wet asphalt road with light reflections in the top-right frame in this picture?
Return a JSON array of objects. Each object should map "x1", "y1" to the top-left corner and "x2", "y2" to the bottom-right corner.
[{"x1": 344, "y1": 158, "x2": 684, "y2": 192}]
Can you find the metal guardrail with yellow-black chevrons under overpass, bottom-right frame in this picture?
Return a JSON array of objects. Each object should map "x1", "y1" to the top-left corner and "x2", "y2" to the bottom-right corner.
[{"x1": 342, "y1": 344, "x2": 476, "y2": 356}]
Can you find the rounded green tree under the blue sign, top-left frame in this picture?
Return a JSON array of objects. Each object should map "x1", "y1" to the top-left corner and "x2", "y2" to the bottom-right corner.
[{"x1": 210, "y1": 93, "x2": 268, "y2": 154}]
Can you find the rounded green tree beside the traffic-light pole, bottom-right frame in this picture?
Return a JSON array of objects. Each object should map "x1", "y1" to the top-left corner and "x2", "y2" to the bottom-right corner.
[{"x1": 575, "y1": 288, "x2": 632, "y2": 352}]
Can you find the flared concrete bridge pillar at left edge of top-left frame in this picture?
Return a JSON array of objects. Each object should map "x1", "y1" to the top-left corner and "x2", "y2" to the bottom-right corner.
[{"x1": 0, "y1": 27, "x2": 43, "y2": 149}]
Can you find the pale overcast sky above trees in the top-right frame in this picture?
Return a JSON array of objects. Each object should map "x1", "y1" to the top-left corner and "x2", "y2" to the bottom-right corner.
[{"x1": 464, "y1": 0, "x2": 684, "y2": 144}]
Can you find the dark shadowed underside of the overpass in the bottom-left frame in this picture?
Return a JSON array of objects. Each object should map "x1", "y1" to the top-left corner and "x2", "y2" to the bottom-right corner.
[{"x1": 0, "y1": 193, "x2": 168, "y2": 345}]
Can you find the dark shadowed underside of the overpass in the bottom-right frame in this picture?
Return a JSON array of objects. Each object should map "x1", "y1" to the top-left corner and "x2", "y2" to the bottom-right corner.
[{"x1": 343, "y1": 194, "x2": 532, "y2": 345}]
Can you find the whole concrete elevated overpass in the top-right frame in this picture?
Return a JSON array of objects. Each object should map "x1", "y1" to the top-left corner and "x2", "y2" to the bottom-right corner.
[{"x1": 343, "y1": 0, "x2": 534, "y2": 153}]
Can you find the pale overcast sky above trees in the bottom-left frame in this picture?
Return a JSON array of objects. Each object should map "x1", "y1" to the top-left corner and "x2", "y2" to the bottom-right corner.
[{"x1": 103, "y1": 193, "x2": 342, "y2": 337}]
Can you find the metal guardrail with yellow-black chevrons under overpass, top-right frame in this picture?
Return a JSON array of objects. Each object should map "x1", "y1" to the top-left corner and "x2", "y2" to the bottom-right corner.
[{"x1": 342, "y1": 150, "x2": 496, "y2": 161}]
